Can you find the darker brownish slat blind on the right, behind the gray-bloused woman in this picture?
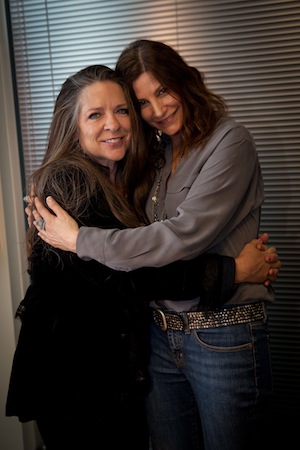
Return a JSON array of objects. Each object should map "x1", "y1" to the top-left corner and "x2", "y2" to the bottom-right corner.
[{"x1": 178, "y1": 1, "x2": 300, "y2": 423}]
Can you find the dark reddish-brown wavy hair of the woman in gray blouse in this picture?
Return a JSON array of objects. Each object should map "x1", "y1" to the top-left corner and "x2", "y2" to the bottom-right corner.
[{"x1": 116, "y1": 39, "x2": 227, "y2": 152}]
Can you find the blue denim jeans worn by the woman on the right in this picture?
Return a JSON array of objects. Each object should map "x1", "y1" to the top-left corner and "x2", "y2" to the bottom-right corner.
[{"x1": 146, "y1": 308, "x2": 272, "y2": 450}]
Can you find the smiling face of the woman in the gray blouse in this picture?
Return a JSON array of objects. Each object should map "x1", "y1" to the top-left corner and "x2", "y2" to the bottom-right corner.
[{"x1": 132, "y1": 72, "x2": 183, "y2": 139}]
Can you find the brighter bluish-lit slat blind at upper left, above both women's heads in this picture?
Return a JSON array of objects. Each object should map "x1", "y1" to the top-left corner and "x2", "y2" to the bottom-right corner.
[{"x1": 9, "y1": 0, "x2": 183, "y2": 178}]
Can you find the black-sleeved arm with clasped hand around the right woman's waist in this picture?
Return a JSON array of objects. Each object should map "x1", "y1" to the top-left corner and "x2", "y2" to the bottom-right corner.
[{"x1": 130, "y1": 233, "x2": 281, "y2": 307}]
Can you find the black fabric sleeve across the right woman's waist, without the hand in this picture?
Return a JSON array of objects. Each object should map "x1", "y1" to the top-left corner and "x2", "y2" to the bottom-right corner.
[{"x1": 122, "y1": 253, "x2": 235, "y2": 308}]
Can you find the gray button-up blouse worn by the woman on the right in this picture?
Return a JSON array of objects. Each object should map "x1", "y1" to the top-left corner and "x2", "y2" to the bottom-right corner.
[{"x1": 76, "y1": 118, "x2": 274, "y2": 310}]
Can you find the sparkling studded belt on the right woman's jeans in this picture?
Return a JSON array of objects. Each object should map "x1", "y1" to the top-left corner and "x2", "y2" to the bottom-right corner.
[{"x1": 153, "y1": 302, "x2": 265, "y2": 333}]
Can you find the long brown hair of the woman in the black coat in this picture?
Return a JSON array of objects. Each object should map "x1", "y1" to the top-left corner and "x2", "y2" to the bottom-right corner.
[{"x1": 27, "y1": 65, "x2": 154, "y2": 255}]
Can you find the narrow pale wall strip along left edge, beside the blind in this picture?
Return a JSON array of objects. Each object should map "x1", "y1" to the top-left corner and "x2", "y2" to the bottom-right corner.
[{"x1": 0, "y1": 0, "x2": 37, "y2": 450}]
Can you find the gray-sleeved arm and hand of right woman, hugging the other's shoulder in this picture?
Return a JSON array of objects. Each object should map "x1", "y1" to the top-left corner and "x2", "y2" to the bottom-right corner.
[{"x1": 37, "y1": 121, "x2": 264, "y2": 270}]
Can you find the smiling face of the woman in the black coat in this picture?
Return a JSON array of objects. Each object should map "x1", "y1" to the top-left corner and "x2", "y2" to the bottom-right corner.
[{"x1": 77, "y1": 81, "x2": 131, "y2": 167}]
